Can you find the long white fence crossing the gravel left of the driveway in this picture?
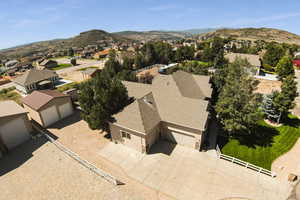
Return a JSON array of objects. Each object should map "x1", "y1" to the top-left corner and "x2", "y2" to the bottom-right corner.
[{"x1": 33, "y1": 123, "x2": 123, "y2": 185}]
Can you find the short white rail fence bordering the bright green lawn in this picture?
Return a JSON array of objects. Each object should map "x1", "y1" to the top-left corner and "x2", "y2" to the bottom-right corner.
[{"x1": 216, "y1": 145, "x2": 276, "y2": 177}]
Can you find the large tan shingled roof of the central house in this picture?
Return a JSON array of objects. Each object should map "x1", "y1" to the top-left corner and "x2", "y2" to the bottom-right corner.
[{"x1": 114, "y1": 71, "x2": 211, "y2": 132}]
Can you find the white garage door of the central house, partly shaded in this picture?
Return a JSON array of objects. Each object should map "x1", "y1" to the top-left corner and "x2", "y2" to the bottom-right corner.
[{"x1": 166, "y1": 130, "x2": 196, "y2": 148}]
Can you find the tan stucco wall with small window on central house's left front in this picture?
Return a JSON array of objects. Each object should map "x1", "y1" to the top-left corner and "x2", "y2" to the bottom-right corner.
[{"x1": 110, "y1": 123, "x2": 146, "y2": 153}]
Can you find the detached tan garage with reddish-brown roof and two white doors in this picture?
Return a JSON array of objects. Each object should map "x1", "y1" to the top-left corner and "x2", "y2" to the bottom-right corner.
[{"x1": 22, "y1": 90, "x2": 74, "y2": 127}]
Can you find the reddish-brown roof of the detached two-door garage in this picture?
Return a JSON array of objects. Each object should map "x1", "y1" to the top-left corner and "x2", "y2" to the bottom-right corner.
[{"x1": 22, "y1": 90, "x2": 68, "y2": 110}]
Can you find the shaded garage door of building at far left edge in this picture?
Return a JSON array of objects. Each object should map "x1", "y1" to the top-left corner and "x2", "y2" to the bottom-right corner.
[{"x1": 0, "y1": 118, "x2": 29, "y2": 149}]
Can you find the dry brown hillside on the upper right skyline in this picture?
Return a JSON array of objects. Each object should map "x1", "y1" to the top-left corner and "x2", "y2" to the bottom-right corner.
[{"x1": 199, "y1": 28, "x2": 300, "y2": 45}]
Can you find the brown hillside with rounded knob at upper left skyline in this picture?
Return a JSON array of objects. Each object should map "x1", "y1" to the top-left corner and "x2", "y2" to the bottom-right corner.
[{"x1": 0, "y1": 30, "x2": 128, "y2": 58}]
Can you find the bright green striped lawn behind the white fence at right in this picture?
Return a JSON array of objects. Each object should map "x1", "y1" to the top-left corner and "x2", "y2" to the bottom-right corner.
[{"x1": 219, "y1": 116, "x2": 300, "y2": 170}]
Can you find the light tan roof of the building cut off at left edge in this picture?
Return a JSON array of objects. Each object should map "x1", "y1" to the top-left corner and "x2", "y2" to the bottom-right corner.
[{"x1": 0, "y1": 101, "x2": 27, "y2": 117}]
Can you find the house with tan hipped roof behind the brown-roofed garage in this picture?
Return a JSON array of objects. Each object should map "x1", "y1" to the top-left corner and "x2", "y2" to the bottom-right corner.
[{"x1": 13, "y1": 69, "x2": 58, "y2": 94}]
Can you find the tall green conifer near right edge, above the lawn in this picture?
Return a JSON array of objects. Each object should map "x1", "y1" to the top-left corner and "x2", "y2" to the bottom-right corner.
[{"x1": 274, "y1": 75, "x2": 298, "y2": 119}]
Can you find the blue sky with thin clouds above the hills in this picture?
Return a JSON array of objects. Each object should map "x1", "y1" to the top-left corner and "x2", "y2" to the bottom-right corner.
[{"x1": 0, "y1": 0, "x2": 300, "y2": 49}]
